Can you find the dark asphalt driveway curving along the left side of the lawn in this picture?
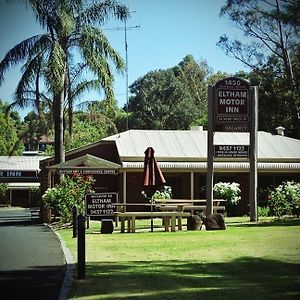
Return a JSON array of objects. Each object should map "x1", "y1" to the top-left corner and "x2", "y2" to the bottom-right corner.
[{"x1": 0, "y1": 208, "x2": 65, "y2": 300}]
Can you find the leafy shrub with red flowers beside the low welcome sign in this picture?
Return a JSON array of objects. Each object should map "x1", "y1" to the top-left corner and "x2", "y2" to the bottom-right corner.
[{"x1": 42, "y1": 174, "x2": 95, "y2": 223}]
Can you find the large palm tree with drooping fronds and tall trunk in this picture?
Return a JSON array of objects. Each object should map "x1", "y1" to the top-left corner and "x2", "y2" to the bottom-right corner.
[{"x1": 0, "y1": 0, "x2": 129, "y2": 163}]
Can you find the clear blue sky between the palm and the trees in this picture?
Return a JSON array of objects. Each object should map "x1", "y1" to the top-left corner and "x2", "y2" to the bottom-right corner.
[{"x1": 0, "y1": 0, "x2": 247, "y2": 116}]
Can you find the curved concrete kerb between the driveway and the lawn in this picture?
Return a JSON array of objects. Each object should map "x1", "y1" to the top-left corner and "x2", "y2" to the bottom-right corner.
[{"x1": 44, "y1": 223, "x2": 75, "y2": 300}]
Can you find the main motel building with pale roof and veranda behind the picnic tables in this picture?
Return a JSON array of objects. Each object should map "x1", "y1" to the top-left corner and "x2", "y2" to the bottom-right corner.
[{"x1": 40, "y1": 126, "x2": 300, "y2": 215}]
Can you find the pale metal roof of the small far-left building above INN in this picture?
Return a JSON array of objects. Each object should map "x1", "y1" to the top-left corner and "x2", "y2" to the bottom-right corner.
[{"x1": 0, "y1": 156, "x2": 47, "y2": 171}]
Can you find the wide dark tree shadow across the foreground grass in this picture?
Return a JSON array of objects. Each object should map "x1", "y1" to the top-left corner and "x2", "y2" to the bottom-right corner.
[{"x1": 71, "y1": 257, "x2": 300, "y2": 300}]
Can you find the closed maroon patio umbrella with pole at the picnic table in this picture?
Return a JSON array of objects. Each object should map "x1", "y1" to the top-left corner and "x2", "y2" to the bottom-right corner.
[{"x1": 144, "y1": 147, "x2": 166, "y2": 231}]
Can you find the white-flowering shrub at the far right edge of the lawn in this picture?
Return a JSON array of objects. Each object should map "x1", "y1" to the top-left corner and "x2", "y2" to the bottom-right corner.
[{"x1": 270, "y1": 181, "x2": 300, "y2": 217}]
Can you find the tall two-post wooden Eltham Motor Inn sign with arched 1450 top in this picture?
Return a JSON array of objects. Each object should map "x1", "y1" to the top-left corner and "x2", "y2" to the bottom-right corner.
[{"x1": 206, "y1": 77, "x2": 258, "y2": 221}]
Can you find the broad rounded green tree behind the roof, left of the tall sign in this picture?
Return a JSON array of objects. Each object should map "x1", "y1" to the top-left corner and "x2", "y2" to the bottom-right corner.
[{"x1": 125, "y1": 55, "x2": 210, "y2": 130}]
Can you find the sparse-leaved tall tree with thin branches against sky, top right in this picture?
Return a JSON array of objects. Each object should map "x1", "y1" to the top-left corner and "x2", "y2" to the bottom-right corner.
[{"x1": 218, "y1": 0, "x2": 300, "y2": 86}]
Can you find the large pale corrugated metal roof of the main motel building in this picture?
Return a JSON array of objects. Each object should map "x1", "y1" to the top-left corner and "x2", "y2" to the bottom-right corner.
[{"x1": 103, "y1": 130, "x2": 300, "y2": 162}]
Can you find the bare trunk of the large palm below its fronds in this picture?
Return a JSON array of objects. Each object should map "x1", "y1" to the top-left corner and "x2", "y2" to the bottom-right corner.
[{"x1": 53, "y1": 91, "x2": 65, "y2": 164}]
